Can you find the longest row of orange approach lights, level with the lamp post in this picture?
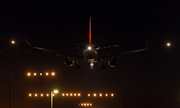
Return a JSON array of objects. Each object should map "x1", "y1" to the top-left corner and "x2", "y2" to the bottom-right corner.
[{"x1": 29, "y1": 93, "x2": 114, "y2": 97}]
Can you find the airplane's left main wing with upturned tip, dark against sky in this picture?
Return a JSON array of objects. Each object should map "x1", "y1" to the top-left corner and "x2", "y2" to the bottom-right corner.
[{"x1": 21, "y1": 40, "x2": 84, "y2": 62}]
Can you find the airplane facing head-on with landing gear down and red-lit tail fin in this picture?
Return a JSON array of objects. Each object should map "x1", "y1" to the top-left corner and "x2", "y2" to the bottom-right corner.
[{"x1": 14, "y1": 17, "x2": 171, "y2": 70}]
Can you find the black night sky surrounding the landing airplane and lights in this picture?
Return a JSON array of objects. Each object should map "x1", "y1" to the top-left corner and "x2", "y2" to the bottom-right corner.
[{"x1": 0, "y1": 1, "x2": 180, "y2": 108}]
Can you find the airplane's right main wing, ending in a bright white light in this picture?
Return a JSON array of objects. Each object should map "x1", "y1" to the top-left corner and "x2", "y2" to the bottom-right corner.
[{"x1": 97, "y1": 43, "x2": 170, "y2": 62}]
